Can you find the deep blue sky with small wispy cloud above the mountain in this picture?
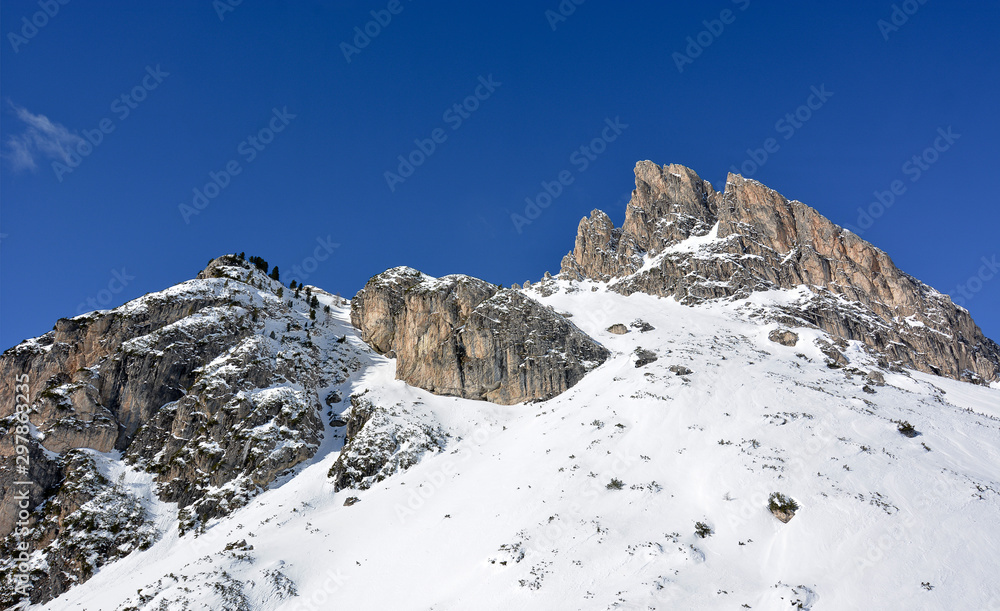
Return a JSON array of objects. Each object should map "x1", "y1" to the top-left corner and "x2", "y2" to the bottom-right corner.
[{"x1": 0, "y1": 0, "x2": 1000, "y2": 348}]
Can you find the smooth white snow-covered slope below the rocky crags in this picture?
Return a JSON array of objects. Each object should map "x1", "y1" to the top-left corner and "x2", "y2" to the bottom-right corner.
[{"x1": 37, "y1": 281, "x2": 1000, "y2": 611}]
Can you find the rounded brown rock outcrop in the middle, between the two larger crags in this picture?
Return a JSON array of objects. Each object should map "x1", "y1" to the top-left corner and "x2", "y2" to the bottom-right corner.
[{"x1": 351, "y1": 267, "x2": 609, "y2": 405}]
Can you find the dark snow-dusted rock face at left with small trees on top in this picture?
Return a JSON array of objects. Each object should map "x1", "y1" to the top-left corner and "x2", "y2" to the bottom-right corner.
[{"x1": 0, "y1": 256, "x2": 360, "y2": 606}]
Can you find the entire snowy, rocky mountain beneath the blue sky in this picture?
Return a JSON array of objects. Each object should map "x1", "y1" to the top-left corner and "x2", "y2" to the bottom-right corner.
[{"x1": 0, "y1": 162, "x2": 1000, "y2": 611}]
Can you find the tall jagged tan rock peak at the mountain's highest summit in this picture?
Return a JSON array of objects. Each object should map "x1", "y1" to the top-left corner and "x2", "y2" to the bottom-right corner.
[{"x1": 560, "y1": 161, "x2": 1000, "y2": 383}]
